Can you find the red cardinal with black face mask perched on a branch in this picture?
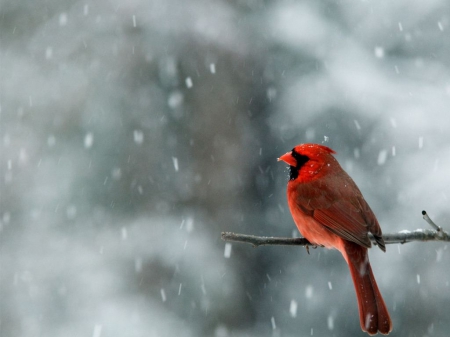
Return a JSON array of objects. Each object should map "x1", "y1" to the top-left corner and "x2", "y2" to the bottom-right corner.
[{"x1": 278, "y1": 144, "x2": 392, "y2": 335}]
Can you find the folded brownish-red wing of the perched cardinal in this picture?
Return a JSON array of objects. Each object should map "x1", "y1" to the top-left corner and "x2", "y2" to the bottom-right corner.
[{"x1": 296, "y1": 172, "x2": 386, "y2": 250}]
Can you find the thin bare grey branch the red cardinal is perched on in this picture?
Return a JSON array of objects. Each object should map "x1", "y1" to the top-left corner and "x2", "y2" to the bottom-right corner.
[{"x1": 222, "y1": 211, "x2": 450, "y2": 247}]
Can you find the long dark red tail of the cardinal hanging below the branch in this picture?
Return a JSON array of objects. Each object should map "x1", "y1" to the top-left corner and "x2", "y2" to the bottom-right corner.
[{"x1": 344, "y1": 242, "x2": 392, "y2": 335}]
